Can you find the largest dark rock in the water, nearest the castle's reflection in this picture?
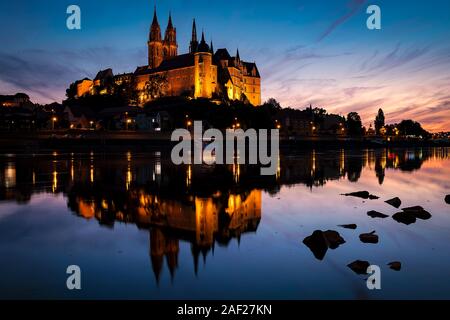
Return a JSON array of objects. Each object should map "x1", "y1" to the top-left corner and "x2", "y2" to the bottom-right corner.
[{"x1": 303, "y1": 230, "x2": 345, "y2": 260}]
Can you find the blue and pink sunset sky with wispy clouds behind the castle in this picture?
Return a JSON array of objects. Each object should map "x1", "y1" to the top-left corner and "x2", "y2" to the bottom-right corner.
[{"x1": 0, "y1": 0, "x2": 450, "y2": 131}]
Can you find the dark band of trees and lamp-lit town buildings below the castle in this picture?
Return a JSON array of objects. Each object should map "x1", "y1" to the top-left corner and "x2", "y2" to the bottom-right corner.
[{"x1": 0, "y1": 90, "x2": 450, "y2": 143}]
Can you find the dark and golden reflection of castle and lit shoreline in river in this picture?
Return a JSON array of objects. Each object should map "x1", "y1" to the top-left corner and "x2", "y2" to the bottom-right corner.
[{"x1": 0, "y1": 148, "x2": 450, "y2": 279}]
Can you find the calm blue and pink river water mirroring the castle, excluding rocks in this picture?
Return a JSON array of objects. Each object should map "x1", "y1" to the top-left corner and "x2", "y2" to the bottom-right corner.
[{"x1": 0, "y1": 148, "x2": 450, "y2": 299}]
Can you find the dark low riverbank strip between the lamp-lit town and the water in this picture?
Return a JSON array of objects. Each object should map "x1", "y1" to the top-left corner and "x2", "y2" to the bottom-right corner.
[{"x1": 0, "y1": 130, "x2": 450, "y2": 151}]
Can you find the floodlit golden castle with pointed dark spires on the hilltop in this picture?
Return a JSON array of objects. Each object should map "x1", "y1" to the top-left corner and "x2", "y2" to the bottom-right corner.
[{"x1": 77, "y1": 8, "x2": 261, "y2": 106}]
